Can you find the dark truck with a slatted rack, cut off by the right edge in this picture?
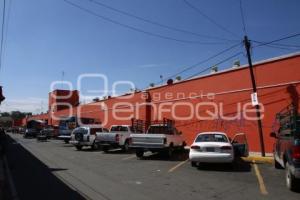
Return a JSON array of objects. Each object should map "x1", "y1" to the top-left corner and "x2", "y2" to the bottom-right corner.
[{"x1": 270, "y1": 106, "x2": 300, "y2": 191}]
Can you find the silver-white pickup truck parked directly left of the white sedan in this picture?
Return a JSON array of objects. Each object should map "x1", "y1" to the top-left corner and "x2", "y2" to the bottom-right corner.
[{"x1": 129, "y1": 123, "x2": 186, "y2": 158}]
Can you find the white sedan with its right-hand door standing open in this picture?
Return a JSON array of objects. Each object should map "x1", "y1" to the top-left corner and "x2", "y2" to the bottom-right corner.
[{"x1": 189, "y1": 132, "x2": 248, "y2": 167}]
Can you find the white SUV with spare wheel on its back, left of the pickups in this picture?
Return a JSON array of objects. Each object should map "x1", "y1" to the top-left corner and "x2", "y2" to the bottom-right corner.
[{"x1": 70, "y1": 126, "x2": 108, "y2": 150}]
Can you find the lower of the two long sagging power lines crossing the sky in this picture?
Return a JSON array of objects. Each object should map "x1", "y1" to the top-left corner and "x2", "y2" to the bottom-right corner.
[{"x1": 63, "y1": 0, "x2": 224, "y2": 45}]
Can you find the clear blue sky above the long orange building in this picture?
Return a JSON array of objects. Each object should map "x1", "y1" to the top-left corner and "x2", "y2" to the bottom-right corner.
[{"x1": 0, "y1": 0, "x2": 300, "y2": 112}]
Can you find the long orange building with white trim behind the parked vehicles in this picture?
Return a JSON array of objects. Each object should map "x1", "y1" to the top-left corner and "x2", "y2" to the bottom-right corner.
[{"x1": 27, "y1": 53, "x2": 300, "y2": 152}]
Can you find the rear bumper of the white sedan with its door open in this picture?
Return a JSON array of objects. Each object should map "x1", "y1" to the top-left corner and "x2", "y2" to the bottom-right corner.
[{"x1": 189, "y1": 153, "x2": 234, "y2": 163}]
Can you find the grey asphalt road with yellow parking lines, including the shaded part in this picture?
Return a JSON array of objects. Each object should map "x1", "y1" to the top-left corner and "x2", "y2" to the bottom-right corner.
[{"x1": 3, "y1": 134, "x2": 300, "y2": 200}]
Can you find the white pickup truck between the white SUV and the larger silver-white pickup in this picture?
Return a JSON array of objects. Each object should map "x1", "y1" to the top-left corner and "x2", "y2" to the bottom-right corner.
[{"x1": 97, "y1": 125, "x2": 134, "y2": 152}]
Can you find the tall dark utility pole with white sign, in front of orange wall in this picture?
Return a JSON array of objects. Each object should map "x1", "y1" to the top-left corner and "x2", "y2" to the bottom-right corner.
[{"x1": 244, "y1": 36, "x2": 266, "y2": 157}]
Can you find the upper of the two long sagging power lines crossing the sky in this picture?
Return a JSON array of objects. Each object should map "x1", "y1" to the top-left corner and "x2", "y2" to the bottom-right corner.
[{"x1": 88, "y1": 0, "x2": 234, "y2": 42}]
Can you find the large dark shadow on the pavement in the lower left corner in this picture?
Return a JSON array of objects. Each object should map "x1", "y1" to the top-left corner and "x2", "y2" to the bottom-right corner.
[{"x1": 6, "y1": 136, "x2": 85, "y2": 200}]
